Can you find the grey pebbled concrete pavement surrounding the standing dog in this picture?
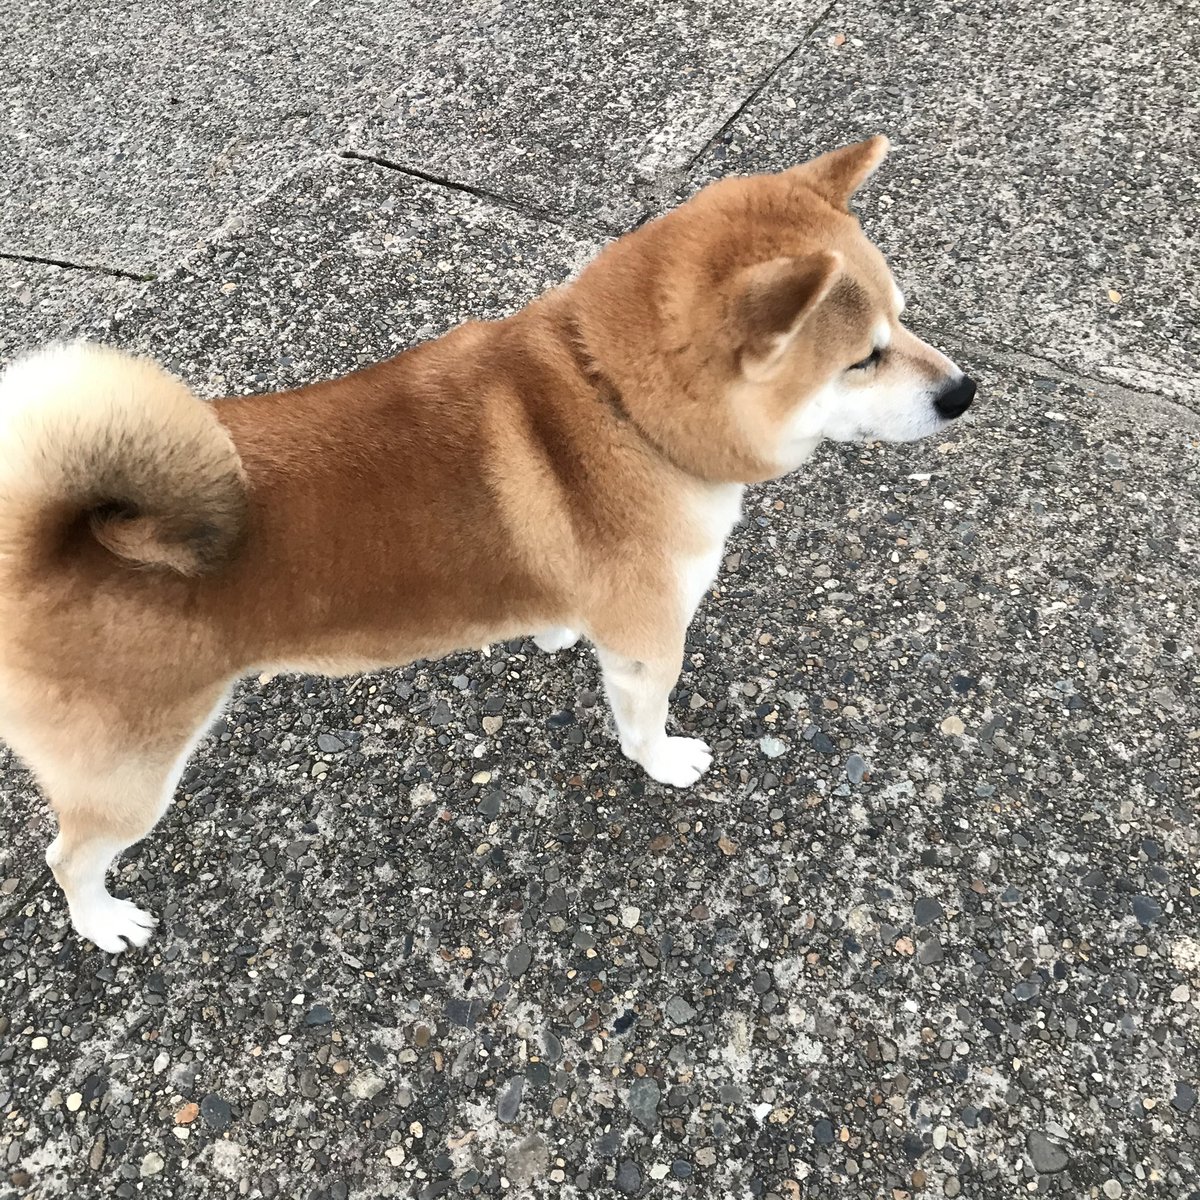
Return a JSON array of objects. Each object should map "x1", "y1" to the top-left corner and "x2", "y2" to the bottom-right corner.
[{"x1": 0, "y1": 0, "x2": 1200, "y2": 1200}]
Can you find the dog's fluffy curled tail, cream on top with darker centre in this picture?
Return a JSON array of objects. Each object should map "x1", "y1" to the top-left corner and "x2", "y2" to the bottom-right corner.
[{"x1": 0, "y1": 342, "x2": 246, "y2": 575}]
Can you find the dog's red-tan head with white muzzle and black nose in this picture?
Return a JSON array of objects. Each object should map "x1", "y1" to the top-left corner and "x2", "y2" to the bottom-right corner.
[{"x1": 580, "y1": 137, "x2": 974, "y2": 481}]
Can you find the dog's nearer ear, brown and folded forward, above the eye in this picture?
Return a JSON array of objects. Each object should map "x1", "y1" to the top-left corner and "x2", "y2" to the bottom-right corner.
[{"x1": 737, "y1": 243, "x2": 841, "y2": 380}]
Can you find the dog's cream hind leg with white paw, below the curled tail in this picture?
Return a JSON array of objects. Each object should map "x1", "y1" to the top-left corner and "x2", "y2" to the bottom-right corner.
[{"x1": 27, "y1": 691, "x2": 224, "y2": 954}]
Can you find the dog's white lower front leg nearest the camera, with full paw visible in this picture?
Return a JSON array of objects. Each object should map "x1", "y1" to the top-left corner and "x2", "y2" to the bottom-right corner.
[{"x1": 596, "y1": 643, "x2": 713, "y2": 787}]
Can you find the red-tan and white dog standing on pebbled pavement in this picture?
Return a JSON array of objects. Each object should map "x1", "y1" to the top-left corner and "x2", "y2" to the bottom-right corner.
[{"x1": 0, "y1": 138, "x2": 974, "y2": 952}]
